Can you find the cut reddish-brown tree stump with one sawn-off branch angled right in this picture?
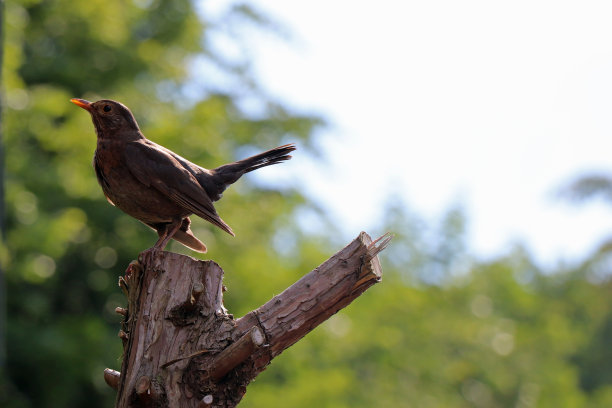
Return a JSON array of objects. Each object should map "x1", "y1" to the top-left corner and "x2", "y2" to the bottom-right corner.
[{"x1": 104, "y1": 232, "x2": 391, "y2": 408}]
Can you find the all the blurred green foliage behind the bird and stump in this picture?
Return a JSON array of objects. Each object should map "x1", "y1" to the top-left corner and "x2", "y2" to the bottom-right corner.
[{"x1": 0, "y1": 0, "x2": 612, "y2": 408}]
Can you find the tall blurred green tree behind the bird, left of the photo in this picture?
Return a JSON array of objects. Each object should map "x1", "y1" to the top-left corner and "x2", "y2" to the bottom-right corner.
[{"x1": 0, "y1": 0, "x2": 321, "y2": 407}]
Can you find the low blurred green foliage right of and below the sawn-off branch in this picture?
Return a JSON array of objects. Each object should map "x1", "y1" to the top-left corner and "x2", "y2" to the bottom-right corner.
[{"x1": 244, "y1": 209, "x2": 612, "y2": 407}]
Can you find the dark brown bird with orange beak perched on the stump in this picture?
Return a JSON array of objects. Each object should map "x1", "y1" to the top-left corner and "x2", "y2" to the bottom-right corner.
[{"x1": 70, "y1": 98, "x2": 295, "y2": 252}]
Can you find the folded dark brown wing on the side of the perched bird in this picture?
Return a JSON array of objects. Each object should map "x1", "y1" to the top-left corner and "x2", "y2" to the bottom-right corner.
[{"x1": 124, "y1": 140, "x2": 234, "y2": 235}]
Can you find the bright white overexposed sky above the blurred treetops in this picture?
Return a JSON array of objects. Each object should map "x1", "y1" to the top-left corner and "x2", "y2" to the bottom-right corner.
[{"x1": 206, "y1": 0, "x2": 612, "y2": 264}]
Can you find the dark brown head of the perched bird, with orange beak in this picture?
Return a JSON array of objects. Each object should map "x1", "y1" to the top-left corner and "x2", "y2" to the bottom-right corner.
[{"x1": 70, "y1": 98, "x2": 140, "y2": 139}]
